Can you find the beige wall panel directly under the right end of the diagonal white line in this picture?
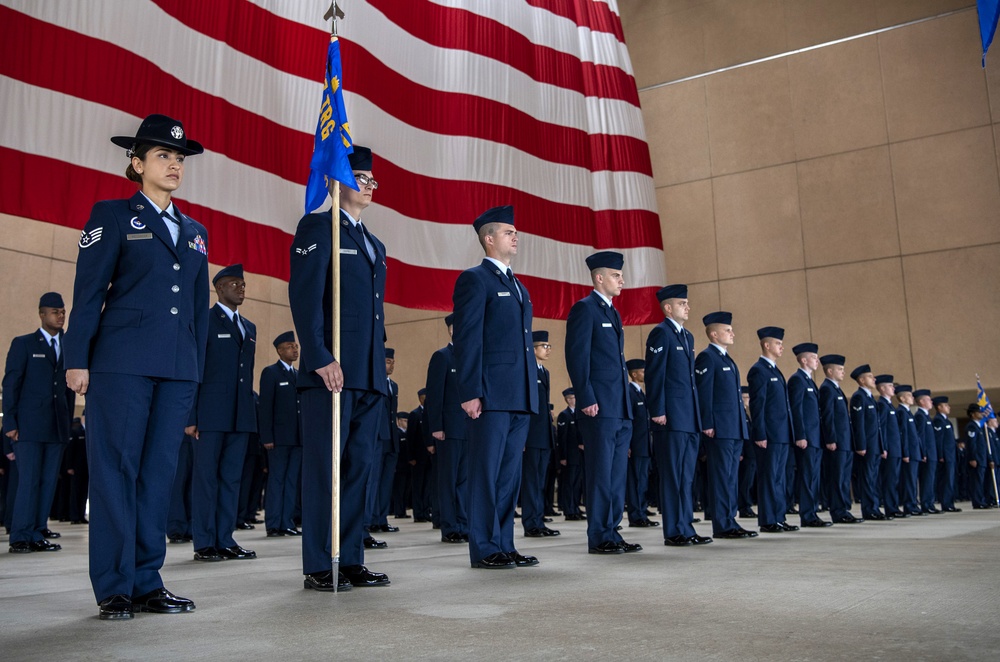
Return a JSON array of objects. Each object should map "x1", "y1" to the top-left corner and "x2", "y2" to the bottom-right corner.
[{"x1": 878, "y1": 11, "x2": 990, "y2": 142}]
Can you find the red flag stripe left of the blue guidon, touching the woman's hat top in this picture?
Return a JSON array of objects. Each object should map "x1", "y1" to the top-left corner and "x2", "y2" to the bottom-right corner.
[{"x1": 0, "y1": 6, "x2": 316, "y2": 187}]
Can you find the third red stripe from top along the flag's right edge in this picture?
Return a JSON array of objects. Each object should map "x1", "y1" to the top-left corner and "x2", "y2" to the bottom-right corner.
[{"x1": 341, "y1": 41, "x2": 653, "y2": 177}]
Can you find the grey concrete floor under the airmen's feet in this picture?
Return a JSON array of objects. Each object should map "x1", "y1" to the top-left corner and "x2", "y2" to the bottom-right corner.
[{"x1": 0, "y1": 504, "x2": 1000, "y2": 662}]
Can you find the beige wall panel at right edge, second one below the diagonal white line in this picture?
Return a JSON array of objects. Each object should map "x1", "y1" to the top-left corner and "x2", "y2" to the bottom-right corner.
[{"x1": 891, "y1": 126, "x2": 1000, "y2": 255}]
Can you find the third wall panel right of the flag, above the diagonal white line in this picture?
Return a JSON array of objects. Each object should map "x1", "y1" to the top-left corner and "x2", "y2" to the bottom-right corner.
[{"x1": 784, "y1": 0, "x2": 876, "y2": 50}]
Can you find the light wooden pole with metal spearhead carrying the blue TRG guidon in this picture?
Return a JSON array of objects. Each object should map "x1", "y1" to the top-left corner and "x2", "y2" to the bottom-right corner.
[{"x1": 323, "y1": 0, "x2": 344, "y2": 593}]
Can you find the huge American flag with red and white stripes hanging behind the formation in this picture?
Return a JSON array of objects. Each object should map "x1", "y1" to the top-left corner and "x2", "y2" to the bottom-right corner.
[{"x1": 7, "y1": 0, "x2": 665, "y2": 324}]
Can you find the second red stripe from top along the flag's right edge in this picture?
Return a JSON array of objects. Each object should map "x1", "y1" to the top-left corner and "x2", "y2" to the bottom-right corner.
[{"x1": 368, "y1": 0, "x2": 639, "y2": 107}]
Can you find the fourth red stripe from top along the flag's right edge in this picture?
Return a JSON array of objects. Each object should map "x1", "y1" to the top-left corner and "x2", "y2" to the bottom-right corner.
[{"x1": 372, "y1": 160, "x2": 663, "y2": 248}]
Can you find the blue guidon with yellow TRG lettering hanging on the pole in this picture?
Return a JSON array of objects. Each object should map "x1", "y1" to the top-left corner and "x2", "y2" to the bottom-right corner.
[{"x1": 306, "y1": 37, "x2": 358, "y2": 214}]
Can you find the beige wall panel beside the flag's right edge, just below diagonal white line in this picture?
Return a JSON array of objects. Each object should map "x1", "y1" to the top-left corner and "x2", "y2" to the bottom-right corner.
[{"x1": 639, "y1": 79, "x2": 712, "y2": 186}]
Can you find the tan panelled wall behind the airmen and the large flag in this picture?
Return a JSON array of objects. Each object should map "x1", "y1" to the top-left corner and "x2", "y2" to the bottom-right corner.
[{"x1": 0, "y1": 0, "x2": 1000, "y2": 418}]
